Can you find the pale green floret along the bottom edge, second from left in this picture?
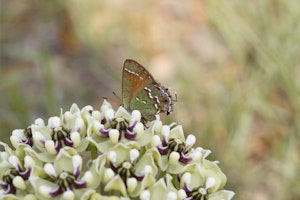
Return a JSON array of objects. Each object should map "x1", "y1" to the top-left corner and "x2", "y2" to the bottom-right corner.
[{"x1": 30, "y1": 147, "x2": 99, "y2": 199}]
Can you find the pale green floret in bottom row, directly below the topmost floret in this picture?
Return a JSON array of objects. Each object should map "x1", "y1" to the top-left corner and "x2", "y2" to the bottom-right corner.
[{"x1": 102, "y1": 143, "x2": 158, "y2": 197}]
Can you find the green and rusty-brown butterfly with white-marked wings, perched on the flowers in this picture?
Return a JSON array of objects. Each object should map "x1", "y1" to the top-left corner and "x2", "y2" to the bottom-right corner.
[{"x1": 122, "y1": 59, "x2": 177, "y2": 121}]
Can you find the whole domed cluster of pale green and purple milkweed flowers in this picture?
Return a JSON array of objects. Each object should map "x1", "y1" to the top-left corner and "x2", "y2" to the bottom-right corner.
[{"x1": 0, "y1": 100, "x2": 234, "y2": 200}]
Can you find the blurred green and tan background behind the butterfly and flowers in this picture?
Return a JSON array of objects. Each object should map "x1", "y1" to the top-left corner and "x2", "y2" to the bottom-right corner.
[{"x1": 0, "y1": 0, "x2": 300, "y2": 200}]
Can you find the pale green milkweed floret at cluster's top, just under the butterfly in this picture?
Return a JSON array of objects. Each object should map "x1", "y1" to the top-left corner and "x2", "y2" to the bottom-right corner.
[{"x1": 87, "y1": 100, "x2": 152, "y2": 152}]
